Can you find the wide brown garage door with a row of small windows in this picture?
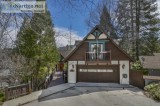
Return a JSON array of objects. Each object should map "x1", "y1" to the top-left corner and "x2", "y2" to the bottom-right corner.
[{"x1": 77, "y1": 65, "x2": 119, "y2": 83}]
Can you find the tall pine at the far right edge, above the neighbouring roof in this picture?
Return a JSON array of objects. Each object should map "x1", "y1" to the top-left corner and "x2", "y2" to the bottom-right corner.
[{"x1": 140, "y1": 0, "x2": 160, "y2": 55}]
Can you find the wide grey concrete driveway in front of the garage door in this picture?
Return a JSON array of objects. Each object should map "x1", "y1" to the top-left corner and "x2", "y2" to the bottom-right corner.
[{"x1": 24, "y1": 87, "x2": 160, "y2": 106}]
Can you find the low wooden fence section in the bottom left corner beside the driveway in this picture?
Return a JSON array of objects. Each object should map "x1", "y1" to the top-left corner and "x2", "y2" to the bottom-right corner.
[{"x1": 5, "y1": 83, "x2": 31, "y2": 100}]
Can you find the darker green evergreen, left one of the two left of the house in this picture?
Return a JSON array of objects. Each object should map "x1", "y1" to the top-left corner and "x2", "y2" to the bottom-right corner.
[{"x1": 16, "y1": 18, "x2": 38, "y2": 83}]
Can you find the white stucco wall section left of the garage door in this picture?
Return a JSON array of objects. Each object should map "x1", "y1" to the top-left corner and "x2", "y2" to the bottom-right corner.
[{"x1": 68, "y1": 61, "x2": 77, "y2": 83}]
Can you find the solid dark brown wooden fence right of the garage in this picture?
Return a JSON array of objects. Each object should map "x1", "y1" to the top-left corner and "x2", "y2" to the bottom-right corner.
[{"x1": 129, "y1": 70, "x2": 145, "y2": 89}]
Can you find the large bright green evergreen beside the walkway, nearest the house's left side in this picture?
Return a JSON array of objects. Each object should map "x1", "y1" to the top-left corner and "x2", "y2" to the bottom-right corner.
[{"x1": 31, "y1": 11, "x2": 59, "y2": 89}]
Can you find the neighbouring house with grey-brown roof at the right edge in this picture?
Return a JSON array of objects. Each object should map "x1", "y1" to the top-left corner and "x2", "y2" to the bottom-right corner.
[{"x1": 139, "y1": 53, "x2": 160, "y2": 76}]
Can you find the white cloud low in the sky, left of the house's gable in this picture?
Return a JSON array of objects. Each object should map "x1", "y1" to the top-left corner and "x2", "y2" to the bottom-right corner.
[{"x1": 54, "y1": 27, "x2": 82, "y2": 47}]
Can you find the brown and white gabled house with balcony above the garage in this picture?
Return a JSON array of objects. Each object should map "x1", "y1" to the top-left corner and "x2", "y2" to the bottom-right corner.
[{"x1": 64, "y1": 26, "x2": 133, "y2": 84}]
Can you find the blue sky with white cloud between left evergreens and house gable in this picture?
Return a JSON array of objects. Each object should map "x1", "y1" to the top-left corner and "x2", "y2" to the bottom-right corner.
[{"x1": 47, "y1": 0, "x2": 160, "y2": 46}]
